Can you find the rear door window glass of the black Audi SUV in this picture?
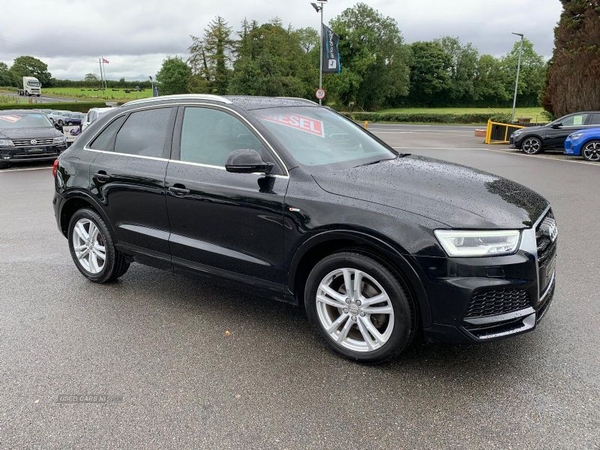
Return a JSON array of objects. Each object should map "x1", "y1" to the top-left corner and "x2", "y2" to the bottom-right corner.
[{"x1": 115, "y1": 108, "x2": 173, "y2": 157}]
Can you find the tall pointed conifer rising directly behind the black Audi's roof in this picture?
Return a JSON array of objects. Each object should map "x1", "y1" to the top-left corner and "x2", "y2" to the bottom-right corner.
[{"x1": 188, "y1": 16, "x2": 234, "y2": 94}]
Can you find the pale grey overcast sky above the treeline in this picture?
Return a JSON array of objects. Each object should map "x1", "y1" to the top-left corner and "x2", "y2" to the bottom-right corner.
[{"x1": 0, "y1": 0, "x2": 562, "y2": 80}]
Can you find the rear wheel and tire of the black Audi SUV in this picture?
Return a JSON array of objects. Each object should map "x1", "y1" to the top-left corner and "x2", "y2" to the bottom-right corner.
[{"x1": 68, "y1": 209, "x2": 129, "y2": 283}]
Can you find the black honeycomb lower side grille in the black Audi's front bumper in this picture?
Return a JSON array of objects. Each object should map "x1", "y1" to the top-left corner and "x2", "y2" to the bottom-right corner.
[{"x1": 465, "y1": 289, "x2": 531, "y2": 317}]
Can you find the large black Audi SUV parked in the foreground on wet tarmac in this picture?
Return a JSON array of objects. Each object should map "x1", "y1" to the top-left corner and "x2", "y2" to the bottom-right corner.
[{"x1": 53, "y1": 95, "x2": 557, "y2": 363}]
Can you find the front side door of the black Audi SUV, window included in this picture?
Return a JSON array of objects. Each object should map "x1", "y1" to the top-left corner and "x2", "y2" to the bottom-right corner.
[{"x1": 165, "y1": 105, "x2": 289, "y2": 289}]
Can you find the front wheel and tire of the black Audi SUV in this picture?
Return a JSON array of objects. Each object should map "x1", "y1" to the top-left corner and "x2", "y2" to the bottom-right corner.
[{"x1": 304, "y1": 252, "x2": 417, "y2": 364}]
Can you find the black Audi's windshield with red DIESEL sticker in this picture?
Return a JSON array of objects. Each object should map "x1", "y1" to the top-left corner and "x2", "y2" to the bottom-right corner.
[{"x1": 252, "y1": 107, "x2": 397, "y2": 166}]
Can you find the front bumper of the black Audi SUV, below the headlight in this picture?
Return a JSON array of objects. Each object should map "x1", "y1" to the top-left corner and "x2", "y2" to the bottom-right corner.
[{"x1": 417, "y1": 209, "x2": 557, "y2": 343}]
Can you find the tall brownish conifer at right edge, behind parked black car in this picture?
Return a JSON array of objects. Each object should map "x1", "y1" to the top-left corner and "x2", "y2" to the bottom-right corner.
[{"x1": 542, "y1": 0, "x2": 600, "y2": 116}]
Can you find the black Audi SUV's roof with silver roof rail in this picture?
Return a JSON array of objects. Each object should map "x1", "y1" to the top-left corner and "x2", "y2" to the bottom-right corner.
[{"x1": 121, "y1": 94, "x2": 317, "y2": 110}]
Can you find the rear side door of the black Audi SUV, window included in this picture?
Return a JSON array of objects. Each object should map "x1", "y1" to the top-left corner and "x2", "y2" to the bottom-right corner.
[{"x1": 88, "y1": 107, "x2": 177, "y2": 268}]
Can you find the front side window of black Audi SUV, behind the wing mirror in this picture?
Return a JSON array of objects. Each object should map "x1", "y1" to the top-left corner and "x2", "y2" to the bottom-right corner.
[{"x1": 180, "y1": 108, "x2": 272, "y2": 167}]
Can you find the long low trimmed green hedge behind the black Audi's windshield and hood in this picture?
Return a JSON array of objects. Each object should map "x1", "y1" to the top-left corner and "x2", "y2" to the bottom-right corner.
[{"x1": 342, "y1": 112, "x2": 511, "y2": 124}]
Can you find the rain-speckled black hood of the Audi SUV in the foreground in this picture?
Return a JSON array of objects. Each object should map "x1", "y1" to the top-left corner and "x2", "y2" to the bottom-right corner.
[{"x1": 312, "y1": 156, "x2": 548, "y2": 229}]
